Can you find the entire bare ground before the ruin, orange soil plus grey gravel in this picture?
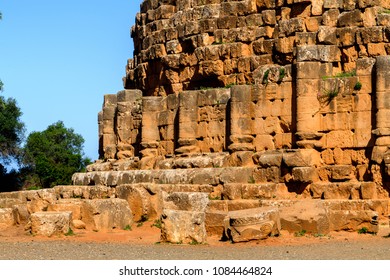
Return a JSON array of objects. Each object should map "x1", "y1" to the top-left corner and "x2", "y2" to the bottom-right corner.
[{"x1": 0, "y1": 223, "x2": 390, "y2": 260}]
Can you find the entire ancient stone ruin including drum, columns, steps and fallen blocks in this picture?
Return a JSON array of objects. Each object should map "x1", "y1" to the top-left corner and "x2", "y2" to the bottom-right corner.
[{"x1": 0, "y1": 0, "x2": 390, "y2": 243}]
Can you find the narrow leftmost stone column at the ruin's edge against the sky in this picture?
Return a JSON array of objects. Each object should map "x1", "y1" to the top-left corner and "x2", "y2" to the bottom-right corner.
[{"x1": 101, "y1": 94, "x2": 117, "y2": 159}]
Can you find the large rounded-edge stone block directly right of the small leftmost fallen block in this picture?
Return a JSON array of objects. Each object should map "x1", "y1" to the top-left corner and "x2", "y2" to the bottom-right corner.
[{"x1": 81, "y1": 198, "x2": 133, "y2": 231}]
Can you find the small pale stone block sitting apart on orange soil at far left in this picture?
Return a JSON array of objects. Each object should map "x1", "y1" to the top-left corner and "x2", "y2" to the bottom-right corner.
[{"x1": 28, "y1": 212, "x2": 72, "y2": 237}]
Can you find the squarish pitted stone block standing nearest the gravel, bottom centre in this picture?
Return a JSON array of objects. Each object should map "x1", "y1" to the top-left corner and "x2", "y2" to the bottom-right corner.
[{"x1": 161, "y1": 209, "x2": 207, "y2": 243}]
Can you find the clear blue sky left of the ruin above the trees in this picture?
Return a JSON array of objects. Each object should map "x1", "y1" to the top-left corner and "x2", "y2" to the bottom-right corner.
[{"x1": 0, "y1": 0, "x2": 141, "y2": 160}]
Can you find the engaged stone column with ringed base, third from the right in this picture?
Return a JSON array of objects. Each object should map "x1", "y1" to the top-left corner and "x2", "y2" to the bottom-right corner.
[{"x1": 229, "y1": 85, "x2": 255, "y2": 152}]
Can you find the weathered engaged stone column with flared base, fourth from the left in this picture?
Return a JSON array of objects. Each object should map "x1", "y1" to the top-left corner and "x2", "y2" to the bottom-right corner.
[{"x1": 176, "y1": 91, "x2": 200, "y2": 154}]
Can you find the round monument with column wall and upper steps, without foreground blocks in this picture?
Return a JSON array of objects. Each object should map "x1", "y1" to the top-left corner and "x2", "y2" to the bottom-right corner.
[{"x1": 91, "y1": 0, "x2": 390, "y2": 217}]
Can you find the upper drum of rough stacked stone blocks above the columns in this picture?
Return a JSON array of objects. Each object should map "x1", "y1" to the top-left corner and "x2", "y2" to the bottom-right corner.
[{"x1": 124, "y1": 0, "x2": 390, "y2": 96}]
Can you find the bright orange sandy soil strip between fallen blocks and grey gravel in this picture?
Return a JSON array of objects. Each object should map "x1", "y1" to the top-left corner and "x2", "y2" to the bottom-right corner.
[{"x1": 0, "y1": 221, "x2": 390, "y2": 247}]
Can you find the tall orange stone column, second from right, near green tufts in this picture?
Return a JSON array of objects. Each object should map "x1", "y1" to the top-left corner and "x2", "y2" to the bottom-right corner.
[{"x1": 296, "y1": 61, "x2": 326, "y2": 148}]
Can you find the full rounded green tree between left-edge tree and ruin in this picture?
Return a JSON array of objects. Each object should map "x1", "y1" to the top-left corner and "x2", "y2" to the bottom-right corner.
[{"x1": 24, "y1": 121, "x2": 90, "y2": 188}]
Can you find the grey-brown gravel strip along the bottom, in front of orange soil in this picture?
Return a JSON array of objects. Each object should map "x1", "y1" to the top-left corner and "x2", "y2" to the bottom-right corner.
[{"x1": 0, "y1": 238, "x2": 390, "y2": 260}]
